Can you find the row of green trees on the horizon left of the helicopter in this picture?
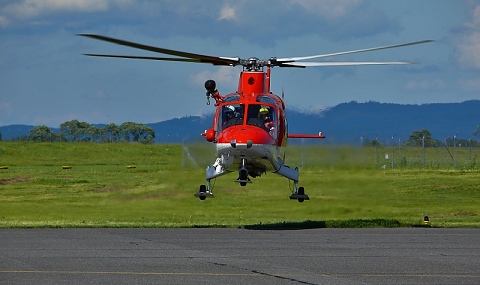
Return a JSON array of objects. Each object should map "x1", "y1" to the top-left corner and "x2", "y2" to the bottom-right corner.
[{"x1": 14, "y1": 120, "x2": 155, "y2": 143}]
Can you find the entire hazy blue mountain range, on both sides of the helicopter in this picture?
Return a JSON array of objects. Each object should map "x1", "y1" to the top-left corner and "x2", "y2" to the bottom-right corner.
[{"x1": 0, "y1": 100, "x2": 480, "y2": 144}]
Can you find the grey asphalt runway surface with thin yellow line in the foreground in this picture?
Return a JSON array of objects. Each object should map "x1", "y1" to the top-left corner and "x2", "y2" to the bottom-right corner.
[{"x1": 0, "y1": 228, "x2": 480, "y2": 284}]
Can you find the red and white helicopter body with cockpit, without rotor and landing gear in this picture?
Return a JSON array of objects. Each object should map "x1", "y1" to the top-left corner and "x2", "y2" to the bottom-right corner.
[{"x1": 202, "y1": 71, "x2": 288, "y2": 177}]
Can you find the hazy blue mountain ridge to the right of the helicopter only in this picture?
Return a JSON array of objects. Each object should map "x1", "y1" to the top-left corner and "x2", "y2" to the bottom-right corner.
[{"x1": 288, "y1": 100, "x2": 480, "y2": 144}]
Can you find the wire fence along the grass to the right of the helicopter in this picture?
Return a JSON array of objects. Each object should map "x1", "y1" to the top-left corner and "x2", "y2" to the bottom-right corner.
[{"x1": 286, "y1": 145, "x2": 480, "y2": 169}]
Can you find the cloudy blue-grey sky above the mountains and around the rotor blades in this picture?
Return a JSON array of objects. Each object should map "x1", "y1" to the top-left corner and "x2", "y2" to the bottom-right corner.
[{"x1": 0, "y1": 0, "x2": 480, "y2": 127}]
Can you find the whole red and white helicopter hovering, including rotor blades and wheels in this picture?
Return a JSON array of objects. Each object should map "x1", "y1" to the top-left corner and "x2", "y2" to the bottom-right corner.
[{"x1": 79, "y1": 34, "x2": 431, "y2": 202}]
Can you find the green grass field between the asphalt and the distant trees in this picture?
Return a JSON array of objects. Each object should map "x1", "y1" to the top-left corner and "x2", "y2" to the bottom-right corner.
[{"x1": 0, "y1": 142, "x2": 480, "y2": 228}]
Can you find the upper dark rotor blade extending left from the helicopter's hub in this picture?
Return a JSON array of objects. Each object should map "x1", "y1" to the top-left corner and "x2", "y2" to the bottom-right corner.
[{"x1": 78, "y1": 34, "x2": 239, "y2": 65}]
